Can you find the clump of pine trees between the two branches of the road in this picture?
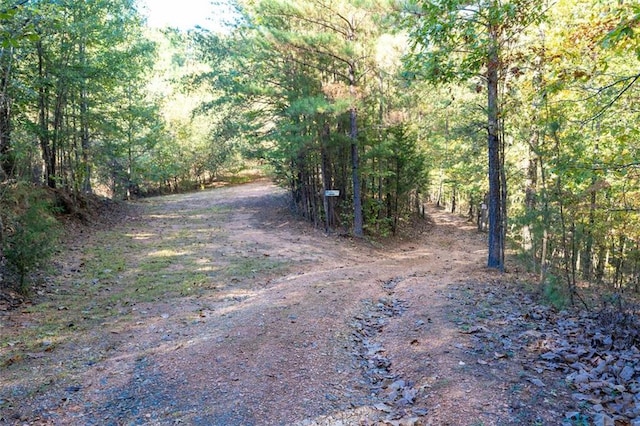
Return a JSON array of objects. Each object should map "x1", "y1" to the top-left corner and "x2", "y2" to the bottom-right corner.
[{"x1": 194, "y1": 0, "x2": 436, "y2": 234}]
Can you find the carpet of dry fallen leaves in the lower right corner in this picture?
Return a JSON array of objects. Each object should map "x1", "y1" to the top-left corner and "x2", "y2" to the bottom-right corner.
[{"x1": 454, "y1": 281, "x2": 640, "y2": 426}]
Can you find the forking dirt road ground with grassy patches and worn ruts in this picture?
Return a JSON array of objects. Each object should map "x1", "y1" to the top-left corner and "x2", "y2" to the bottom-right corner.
[{"x1": 0, "y1": 181, "x2": 635, "y2": 425}]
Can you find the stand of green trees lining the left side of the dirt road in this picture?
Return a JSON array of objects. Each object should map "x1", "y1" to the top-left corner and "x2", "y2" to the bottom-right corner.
[{"x1": 0, "y1": 0, "x2": 232, "y2": 198}]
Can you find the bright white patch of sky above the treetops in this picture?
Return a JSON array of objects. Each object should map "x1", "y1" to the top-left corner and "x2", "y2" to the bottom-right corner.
[{"x1": 140, "y1": 0, "x2": 235, "y2": 31}]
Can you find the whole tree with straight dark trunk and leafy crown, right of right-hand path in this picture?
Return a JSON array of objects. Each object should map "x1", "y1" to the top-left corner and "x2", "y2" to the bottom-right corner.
[{"x1": 405, "y1": 0, "x2": 541, "y2": 270}]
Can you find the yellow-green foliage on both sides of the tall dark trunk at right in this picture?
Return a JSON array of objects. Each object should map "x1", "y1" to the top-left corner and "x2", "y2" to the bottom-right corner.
[{"x1": 403, "y1": 0, "x2": 640, "y2": 292}]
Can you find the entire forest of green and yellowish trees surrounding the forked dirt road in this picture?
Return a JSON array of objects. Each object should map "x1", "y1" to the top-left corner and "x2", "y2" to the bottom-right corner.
[{"x1": 0, "y1": 0, "x2": 640, "y2": 305}]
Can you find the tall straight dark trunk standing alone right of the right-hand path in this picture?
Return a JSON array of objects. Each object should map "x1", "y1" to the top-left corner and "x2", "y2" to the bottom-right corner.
[{"x1": 487, "y1": 27, "x2": 505, "y2": 271}]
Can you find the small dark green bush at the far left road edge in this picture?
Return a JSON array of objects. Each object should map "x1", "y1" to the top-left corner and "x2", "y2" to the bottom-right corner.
[{"x1": 0, "y1": 183, "x2": 59, "y2": 294}]
